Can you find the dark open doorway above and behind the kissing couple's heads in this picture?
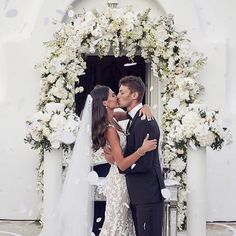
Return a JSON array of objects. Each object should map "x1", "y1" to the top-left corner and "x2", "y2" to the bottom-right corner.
[{"x1": 75, "y1": 56, "x2": 146, "y2": 115}]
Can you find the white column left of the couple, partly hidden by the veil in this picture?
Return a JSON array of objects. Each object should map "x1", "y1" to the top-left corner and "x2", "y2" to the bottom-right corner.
[{"x1": 43, "y1": 149, "x2": 63, "y2": 221}]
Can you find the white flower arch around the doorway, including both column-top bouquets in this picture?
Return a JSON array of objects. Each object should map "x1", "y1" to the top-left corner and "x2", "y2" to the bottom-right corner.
[{"x1": 25, "y1": 7, "x2": 229, "y2": 229}]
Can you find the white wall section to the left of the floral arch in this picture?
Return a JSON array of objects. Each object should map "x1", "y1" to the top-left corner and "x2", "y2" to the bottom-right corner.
[{"x1": 0, "y1": 0, "x2": 74, "y2": 219}]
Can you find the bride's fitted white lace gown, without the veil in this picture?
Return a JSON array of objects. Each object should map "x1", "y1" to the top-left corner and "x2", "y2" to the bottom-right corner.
[{"x1": 99, "y1": 131, "x2": 135, "y2": 236}]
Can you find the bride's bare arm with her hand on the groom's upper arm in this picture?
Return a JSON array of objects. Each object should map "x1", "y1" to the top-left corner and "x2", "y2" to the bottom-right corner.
[{"x1": 107, "y1": 127, "x2": 157, "y2": 171}]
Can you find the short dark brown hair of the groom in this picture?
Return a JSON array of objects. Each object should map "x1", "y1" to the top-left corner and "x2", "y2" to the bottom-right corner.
[{"x1": 119, "y1": 75, "x2": 145, "y2": 102}]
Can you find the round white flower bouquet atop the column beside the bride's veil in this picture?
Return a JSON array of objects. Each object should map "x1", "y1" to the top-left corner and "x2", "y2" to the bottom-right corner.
[{"x1": 25, "y1": 103, "x2": 79, "y2": 151}]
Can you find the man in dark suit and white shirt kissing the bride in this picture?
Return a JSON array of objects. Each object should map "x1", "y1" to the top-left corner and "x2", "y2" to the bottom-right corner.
[{"x1": 117, "y1": 76, "x2": 165, "y2": 236}]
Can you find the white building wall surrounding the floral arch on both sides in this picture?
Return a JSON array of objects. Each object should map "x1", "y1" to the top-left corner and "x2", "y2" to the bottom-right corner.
[{"x1": 0, "y1": 0, "x2": 236, "y2": 220}]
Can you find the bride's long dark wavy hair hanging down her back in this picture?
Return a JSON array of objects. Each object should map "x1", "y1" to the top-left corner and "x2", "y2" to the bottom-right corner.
[{"x1": 90, "y1": 85, "x2": 109, "y2": 151}]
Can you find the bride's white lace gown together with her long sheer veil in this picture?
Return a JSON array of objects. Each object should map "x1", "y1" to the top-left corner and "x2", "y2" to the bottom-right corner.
[{"x1": 39, "y1": 95, "x2": 135, "y2": 236}]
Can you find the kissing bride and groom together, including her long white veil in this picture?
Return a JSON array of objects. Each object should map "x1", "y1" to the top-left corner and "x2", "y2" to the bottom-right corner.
[{"x1": 40, "y1": 76, "x2": 165, "y2": 236}]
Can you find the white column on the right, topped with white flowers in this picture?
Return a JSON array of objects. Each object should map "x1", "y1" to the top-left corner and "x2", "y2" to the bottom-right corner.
[{"x1": 187, "y1": 148, "x2": 206, "y2": 236}]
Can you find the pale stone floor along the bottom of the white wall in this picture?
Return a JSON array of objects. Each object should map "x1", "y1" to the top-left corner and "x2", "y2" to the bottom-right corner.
[{"x1": 0, "y1": 220, "x2": 236, "y2": 236}]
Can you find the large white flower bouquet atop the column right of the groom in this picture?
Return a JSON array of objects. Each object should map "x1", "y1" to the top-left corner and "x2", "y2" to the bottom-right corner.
[{"x1": 168, "y1": 104, "x2": 232, "y2": 151}]
